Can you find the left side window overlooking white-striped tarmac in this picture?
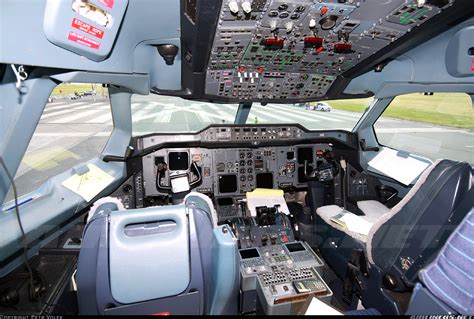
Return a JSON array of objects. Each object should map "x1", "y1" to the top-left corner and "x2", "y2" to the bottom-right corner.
[{"x1": 5, "y1": 83, "x2": 113, "y2": 202}]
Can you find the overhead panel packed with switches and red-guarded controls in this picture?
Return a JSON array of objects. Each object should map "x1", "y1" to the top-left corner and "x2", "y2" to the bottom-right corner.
[{"x1": 168, "y1": 0, "x2": 465, "y2": 103}]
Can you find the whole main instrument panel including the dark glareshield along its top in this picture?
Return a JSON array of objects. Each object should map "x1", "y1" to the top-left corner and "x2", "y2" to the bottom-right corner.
[{"x1": 128, "y1": 124, "x2": 358, "y2": 221}]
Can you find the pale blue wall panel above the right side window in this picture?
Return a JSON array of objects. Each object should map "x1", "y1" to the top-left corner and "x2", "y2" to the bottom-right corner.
[{"x1": 344, "y1": 19, "x2": 474, "y2": 98}]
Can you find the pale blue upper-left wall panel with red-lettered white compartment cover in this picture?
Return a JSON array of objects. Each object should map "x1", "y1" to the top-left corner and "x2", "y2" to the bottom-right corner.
[{"x1": 0, "y1": 0, "x2": 181, "y2": 90}]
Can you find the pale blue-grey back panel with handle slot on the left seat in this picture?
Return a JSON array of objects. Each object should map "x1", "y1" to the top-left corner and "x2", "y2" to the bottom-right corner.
[{"x1": 109, "y1": 206, "x2": 191, "y2": 304}]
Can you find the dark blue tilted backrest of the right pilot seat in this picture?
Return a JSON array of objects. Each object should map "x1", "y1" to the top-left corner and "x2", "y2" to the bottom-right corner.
[{"x1": 367, "y1": 160, "x2": 473, "y2": 270}]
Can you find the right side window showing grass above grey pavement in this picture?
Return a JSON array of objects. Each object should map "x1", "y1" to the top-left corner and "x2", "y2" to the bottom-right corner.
[{"x1": 374, "y1": 93, "x2": 474, "y2": 165}]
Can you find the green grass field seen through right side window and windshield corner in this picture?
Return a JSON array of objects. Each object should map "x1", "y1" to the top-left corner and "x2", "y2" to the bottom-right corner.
[{"x1": 329, "y1": 93, "x2": 474, "y2": 129}]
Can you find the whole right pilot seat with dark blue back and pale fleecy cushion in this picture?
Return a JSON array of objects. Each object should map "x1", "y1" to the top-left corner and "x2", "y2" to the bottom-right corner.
[{"x1": 316, "y1": 160, "x2": 473, "y2": 312}]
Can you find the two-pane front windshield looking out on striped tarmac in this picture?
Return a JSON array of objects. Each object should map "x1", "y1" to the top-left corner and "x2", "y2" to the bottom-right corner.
[{"x1": 132, "y1": 94, "x2": 372, "y2": 136}]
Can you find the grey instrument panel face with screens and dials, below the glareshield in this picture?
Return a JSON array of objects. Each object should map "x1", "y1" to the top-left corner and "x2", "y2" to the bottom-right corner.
[{"x1": 143, "y1": 144, "x2": 332, "y2": 197}]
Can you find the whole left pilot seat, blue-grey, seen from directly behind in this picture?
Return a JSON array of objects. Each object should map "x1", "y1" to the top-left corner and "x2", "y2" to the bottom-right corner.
[{"x1": 77, "y1": 193, "x2": 239, "y2": 315}]
